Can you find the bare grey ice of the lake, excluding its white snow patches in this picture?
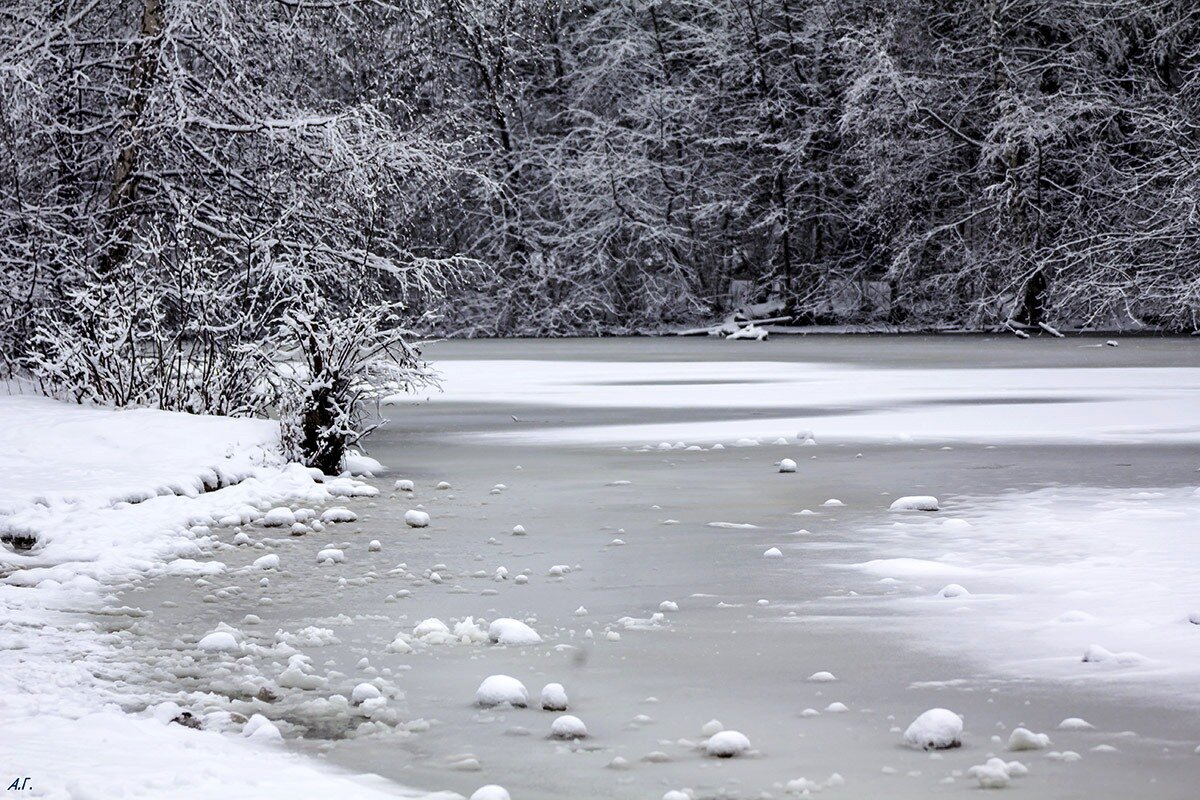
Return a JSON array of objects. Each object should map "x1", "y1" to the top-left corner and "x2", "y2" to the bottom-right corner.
[{"x1": 118, "y1": 337, "x2": 1200, "y2": 800}]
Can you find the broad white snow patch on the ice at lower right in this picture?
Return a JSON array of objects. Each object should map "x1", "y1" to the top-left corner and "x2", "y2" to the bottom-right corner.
[{"x1": 853, "y1": 487, "x2": 1200, "y2": 697}]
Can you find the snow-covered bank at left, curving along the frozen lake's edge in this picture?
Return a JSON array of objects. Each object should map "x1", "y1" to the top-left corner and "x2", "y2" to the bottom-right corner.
[{"x1": 0, "y1": 396, "x2": 455, "y2": 800}]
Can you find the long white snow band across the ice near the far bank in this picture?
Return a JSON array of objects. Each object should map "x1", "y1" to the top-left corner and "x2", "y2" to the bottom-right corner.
[{"x1": 400, "y1": 360, "x2": 1200, "y2": 447}]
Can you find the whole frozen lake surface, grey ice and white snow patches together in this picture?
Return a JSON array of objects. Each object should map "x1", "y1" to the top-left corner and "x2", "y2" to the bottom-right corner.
[{"x1": 116, "y1": 337, "x2": 1200, "y2": 800}]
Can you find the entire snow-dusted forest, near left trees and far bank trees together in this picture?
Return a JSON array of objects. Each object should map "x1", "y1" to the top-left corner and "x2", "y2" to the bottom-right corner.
[{"x1": 0, "y1": 0, "x2": 1200, "y2": 357}]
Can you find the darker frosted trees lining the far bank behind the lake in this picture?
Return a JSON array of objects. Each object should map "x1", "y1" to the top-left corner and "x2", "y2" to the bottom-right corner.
[{"x1": 410, "y1": 0, "x2": 1200, "y2": 335}]
